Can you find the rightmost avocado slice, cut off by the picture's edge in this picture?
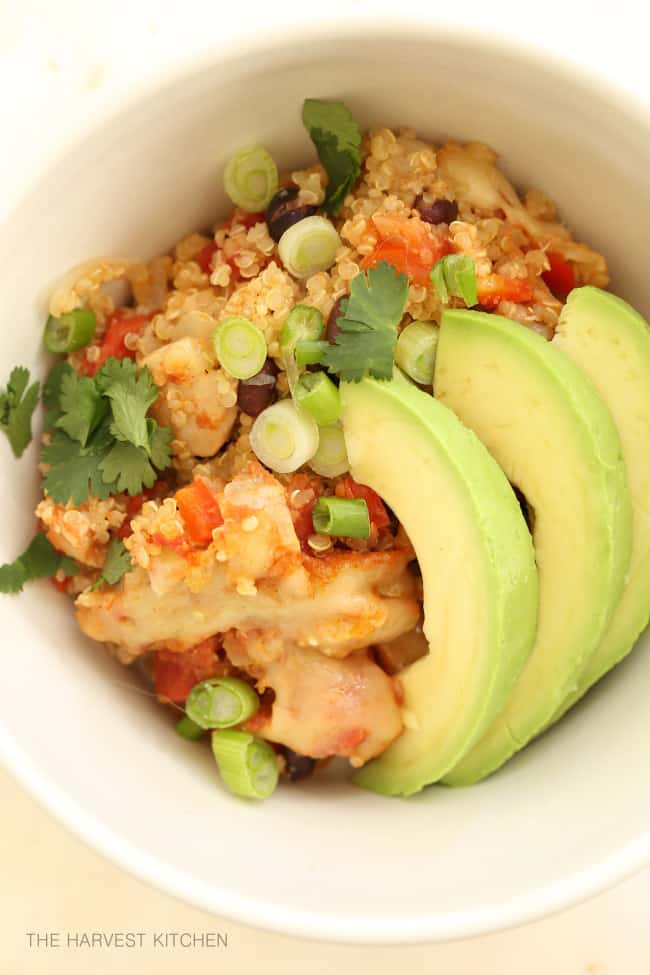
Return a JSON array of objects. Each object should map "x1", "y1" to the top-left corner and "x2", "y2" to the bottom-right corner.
[{"x1": 553, "y1": 287, "x2": 650, "y2": 720}]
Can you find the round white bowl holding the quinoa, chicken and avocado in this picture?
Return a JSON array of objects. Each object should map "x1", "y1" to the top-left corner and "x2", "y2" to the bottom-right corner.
[{"x1": 0, "y1": 23, "x2": 650, "y2": 942}]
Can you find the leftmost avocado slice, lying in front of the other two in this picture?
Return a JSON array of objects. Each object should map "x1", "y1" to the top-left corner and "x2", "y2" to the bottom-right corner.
[{"x1": 341, "y1": 369, "x2": 537, "y2": 796}]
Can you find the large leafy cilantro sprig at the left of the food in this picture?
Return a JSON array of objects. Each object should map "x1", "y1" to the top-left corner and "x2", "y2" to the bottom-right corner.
[{"x1": 41, "y1": 358, "x2": 172, "y2": 504}]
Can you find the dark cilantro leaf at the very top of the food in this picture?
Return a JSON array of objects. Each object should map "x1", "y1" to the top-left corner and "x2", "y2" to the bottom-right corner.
[{"x1": 302, "y1": 98, "x2": 361, "y2": 215}]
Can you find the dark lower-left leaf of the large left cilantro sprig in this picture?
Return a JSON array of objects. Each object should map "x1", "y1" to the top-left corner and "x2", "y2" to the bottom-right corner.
[{"x1": 41, "y1": 420, "x2": 118, "y2": 504}]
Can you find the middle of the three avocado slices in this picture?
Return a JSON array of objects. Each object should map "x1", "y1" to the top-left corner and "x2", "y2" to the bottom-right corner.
[{"x1": 434, "y1": 310, "x2": 631, "y2": 785}]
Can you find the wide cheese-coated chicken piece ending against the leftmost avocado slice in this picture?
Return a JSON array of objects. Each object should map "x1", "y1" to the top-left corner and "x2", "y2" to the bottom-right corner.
[{"x1": 77, "y1": 463, "x2": 419, "y2": 656}]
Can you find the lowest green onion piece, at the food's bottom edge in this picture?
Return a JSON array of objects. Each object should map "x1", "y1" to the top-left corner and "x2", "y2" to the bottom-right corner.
[{"x1": 212, "y1": 731, "x2": 279, "y2": 799}]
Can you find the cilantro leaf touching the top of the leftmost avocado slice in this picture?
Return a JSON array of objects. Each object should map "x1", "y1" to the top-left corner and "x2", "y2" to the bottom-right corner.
[{"x1": 321, "y1": 261, "x2": 408, "y2": 382}]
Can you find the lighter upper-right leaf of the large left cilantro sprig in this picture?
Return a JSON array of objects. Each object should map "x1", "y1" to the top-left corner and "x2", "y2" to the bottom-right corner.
[{"x1": 97, "y1": 359, "x2": 158, "y2": 450}]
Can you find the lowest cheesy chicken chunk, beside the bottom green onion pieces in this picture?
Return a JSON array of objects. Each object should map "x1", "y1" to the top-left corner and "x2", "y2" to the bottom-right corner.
[{"x1": 235, "y1": 640, "x2": 402, "y2": 766}]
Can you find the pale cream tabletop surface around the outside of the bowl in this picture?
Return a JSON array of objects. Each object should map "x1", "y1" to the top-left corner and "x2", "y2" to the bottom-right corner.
[{"x1": 0, "y1": 0, "x2": 650, "y2": 975}]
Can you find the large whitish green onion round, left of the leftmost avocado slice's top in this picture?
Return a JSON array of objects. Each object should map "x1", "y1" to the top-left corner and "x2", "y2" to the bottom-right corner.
[{"x1": 250, "y1": 399, "x2": 318, "y2": 474}]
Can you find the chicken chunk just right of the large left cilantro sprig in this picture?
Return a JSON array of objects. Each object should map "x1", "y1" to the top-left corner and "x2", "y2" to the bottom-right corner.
[{"x1": 140, "y1": 336, "x2": 237, "y2": 457}]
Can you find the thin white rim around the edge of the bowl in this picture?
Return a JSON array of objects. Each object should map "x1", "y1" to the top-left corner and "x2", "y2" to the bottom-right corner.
[{"x1": 0, "y1": 12, "x2": 650, "y2": 945}]
